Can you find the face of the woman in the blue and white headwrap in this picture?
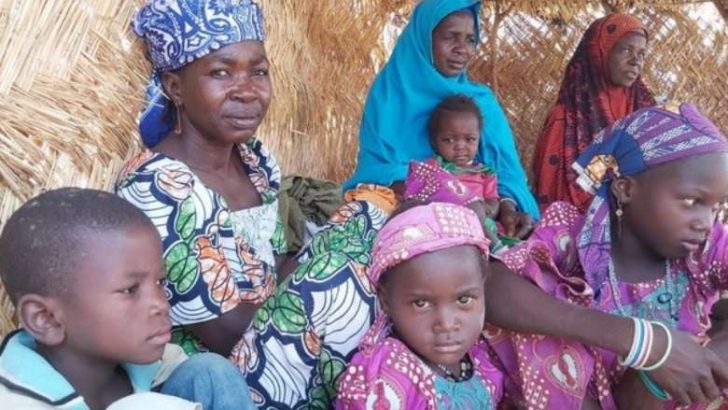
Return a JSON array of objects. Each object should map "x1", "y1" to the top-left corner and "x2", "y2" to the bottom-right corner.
[{"x1": 164, "y1": 41, "x2": 273, "y2": 144}]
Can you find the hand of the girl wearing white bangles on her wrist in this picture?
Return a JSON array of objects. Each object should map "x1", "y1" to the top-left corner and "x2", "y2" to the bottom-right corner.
[{"x1": 650, "y1": 330, "x2": 728, "y2": 405}]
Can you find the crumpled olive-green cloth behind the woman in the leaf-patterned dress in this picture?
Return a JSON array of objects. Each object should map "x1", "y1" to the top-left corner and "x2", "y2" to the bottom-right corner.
[{"x1": 278, "y1": 176, "x2": 344, "y2": 253}]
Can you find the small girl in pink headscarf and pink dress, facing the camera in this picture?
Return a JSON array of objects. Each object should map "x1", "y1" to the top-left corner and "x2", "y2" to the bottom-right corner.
[{"x1": 336, "y1": 203, "x2": 503, "y2": 409}]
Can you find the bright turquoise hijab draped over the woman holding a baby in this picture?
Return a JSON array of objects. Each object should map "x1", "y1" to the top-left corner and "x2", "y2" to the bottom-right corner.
[{"x1": 343, "y1": 0, "x2": 539, "y2": 219}]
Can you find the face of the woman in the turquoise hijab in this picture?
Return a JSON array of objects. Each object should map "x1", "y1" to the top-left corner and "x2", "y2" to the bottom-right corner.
[{"x1": 432, "y1": 11, "x2": 477, "y2": 77}]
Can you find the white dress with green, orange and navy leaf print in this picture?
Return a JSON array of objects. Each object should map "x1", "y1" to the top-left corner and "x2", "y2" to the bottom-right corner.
[{"x1": 116, "y1": 139, "x2": 385, "y2": 408}]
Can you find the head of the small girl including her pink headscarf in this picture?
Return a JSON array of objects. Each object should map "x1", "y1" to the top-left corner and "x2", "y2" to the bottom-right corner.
[{"x1": 369, "y1": 202, "x2": 489, "y2": 366}]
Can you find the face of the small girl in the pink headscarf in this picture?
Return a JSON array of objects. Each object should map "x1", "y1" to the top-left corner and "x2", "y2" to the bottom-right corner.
[{"x1": 380, "y1": 246, "x2": 485, "y2": 374}]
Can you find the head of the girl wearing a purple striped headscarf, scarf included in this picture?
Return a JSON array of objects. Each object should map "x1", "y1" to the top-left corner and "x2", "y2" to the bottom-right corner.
[{"x1": 574, "y1": 104, "x2": 728, "y2": 259}]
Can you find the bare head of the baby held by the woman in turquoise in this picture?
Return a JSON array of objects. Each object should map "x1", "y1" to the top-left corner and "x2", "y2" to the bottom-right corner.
[{"x1": 427, "y1": 94, "x2": 483, "y2": 167}]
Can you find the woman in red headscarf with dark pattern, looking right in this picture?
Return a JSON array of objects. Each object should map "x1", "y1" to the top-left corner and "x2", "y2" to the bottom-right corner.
[{"x1": 533, "y1": 13, "x2": 655, "y2": 211}]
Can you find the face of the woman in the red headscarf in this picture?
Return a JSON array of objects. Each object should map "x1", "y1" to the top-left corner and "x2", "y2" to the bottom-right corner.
[{"x1": 607, "y1": 33, "x2": 647, "y2": 87}]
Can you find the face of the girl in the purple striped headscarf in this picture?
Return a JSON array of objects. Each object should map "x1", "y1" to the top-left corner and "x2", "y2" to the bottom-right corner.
[{"x1": 612, "y1": 153, "x2": 728, "y2": 259}]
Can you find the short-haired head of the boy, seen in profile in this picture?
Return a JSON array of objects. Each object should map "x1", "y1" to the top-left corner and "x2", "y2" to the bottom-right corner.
[{"x1": 0, "y1": 188, "x2": 170, "y2": 363}]
